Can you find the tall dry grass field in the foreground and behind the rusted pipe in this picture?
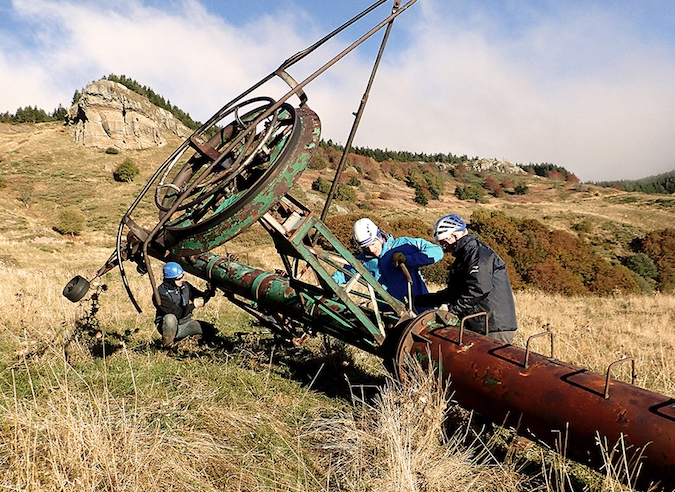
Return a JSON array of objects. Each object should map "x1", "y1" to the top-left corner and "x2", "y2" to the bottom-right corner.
[{"x1": 0, "y1": 266, "x2": 675, "y2": 492}]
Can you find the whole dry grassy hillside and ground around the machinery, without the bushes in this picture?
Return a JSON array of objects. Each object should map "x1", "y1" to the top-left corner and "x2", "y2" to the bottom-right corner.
[{"x1": 0, "y1": 123, "x2": 675, "y2": 491}]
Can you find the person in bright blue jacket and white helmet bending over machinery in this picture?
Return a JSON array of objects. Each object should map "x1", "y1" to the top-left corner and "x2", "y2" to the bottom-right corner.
[{"x1": 333, "y1": 218, "x2": 443, "y2": 310}]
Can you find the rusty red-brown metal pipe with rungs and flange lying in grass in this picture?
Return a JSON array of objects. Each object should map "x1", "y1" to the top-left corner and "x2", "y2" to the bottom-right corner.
[{"x1": 397, "y1": 311, "x2": 675, "y2": 490}]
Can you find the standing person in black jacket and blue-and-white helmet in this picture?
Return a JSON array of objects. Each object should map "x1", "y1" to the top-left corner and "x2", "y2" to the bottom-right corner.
[{"x1": 415, "y1": 214, "x2": 518, "y2": 343}]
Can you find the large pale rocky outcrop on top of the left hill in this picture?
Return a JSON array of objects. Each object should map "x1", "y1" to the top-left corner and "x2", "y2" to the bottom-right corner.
[{"x1": 67, "y1": 80, "x2": 192, "y2": 150}]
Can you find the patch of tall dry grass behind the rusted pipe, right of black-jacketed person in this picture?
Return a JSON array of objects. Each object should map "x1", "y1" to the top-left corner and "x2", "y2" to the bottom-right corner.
[{"x1": 514, "y1": 292, "x2": 675, "y2": 395}]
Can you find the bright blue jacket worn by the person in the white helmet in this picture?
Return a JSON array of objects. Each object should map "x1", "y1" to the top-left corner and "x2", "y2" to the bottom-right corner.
[{"x1": 333, "y1": 236, "x2": 443, "y2": 310}]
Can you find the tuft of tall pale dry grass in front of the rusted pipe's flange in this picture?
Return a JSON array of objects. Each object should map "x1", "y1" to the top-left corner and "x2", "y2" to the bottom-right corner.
[{"x1": 313, "y1": 360, "x2": 528, "y2": 492}]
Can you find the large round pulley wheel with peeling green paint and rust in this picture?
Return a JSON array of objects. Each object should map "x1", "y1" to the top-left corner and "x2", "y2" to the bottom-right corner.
[{"x1": 155, "y1": 97, "x2": 320, "y2": 256}]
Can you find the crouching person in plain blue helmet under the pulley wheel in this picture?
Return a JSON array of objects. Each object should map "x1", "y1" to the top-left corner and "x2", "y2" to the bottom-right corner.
[{"x1": 153, "y1": 261, "x2": 215, "y2": 348}]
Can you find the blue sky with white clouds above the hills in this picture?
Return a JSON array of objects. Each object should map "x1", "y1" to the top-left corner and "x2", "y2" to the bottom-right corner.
[{"x1": 0, "y1": 0, "x2": 675, "y2": 182}]
